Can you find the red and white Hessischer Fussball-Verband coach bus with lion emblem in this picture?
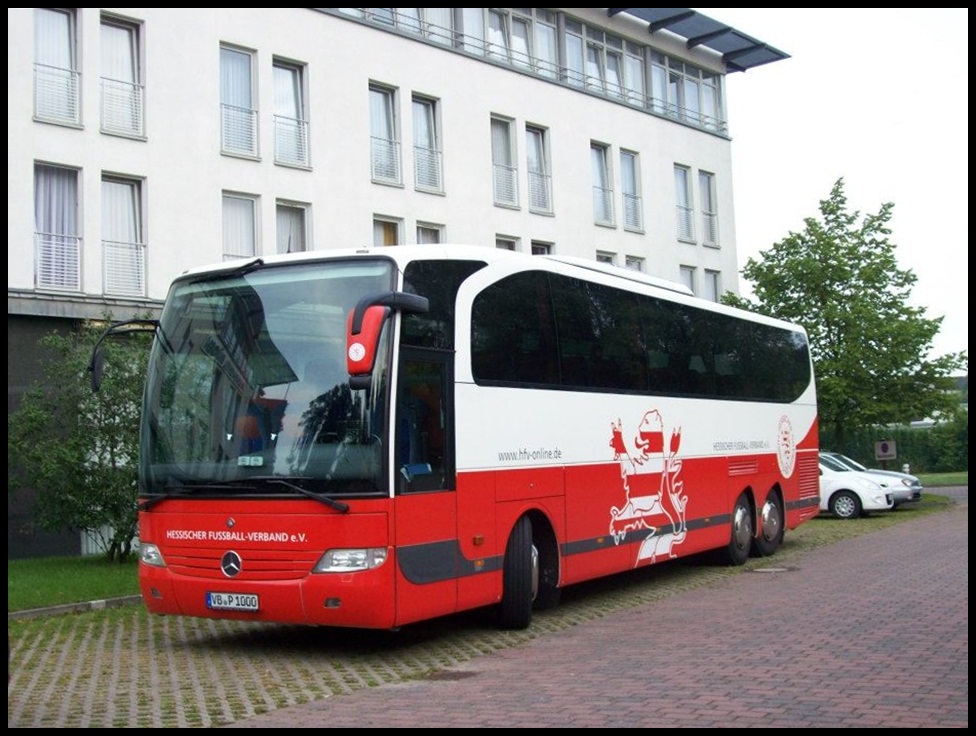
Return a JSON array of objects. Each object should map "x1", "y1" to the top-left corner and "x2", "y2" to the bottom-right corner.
[{"x1": 96, "y1": 245, "x2": 820, "y2": 629}]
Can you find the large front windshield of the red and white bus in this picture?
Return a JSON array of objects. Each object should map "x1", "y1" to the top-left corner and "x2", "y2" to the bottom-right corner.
[{"x1": 140, "y1": 258, "x2": 395, "y2": 496}]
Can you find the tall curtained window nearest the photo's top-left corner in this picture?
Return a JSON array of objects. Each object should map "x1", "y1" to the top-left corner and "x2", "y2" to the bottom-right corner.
[{"x1": 34, "y1": 8, "x2": 81, "y2": 125}]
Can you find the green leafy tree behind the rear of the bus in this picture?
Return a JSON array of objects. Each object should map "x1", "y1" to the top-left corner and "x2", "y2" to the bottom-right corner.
[{"x1": 722, "y1": 178, "x2": 968, "y2": 447}]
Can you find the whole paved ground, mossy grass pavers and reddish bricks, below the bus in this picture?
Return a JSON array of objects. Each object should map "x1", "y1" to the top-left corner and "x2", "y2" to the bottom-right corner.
[{"x1": 7, "y1": 489, "x2": 969, "y2": 728}]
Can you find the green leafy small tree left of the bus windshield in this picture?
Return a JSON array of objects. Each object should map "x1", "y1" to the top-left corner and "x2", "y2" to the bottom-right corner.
[{"x1": 7, "y1": 318, "x2": 148, "y2": 562}]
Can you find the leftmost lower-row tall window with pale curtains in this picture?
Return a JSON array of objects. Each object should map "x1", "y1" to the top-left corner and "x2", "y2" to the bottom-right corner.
[{"x1": 34, "y1": 164, "x2": 81, "y2": 291}]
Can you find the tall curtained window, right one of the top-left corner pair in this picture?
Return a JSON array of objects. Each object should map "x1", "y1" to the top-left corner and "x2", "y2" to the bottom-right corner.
[{"x1": 101, "y1": 17, "x2": 145, "y2": 136}]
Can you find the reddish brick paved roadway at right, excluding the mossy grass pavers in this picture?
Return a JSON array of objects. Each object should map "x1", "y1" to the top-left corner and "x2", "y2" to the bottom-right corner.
[{"x1": 232, "y1": 491, "x2": 969, "y2": 728}]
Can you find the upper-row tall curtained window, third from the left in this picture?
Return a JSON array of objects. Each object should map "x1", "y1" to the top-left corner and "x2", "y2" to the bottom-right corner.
[{"x1": 220, "y1": 46, "x2": 258, "y2": 156}]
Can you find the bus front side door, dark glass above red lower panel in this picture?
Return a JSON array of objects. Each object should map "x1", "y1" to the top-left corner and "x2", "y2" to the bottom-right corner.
[{"x1": 391, "y1": 346, "x2": 457, "y2": 623}]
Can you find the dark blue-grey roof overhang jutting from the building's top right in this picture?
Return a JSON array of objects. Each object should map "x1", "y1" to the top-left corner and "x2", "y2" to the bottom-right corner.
[{"x1": 607, "y1": 8, "x2": 790, "y2": 73}]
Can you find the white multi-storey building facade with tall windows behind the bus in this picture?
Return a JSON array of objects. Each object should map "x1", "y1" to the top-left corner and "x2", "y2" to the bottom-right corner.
[{"x1": 7, "y1": 8, "x2": 786, "y2": 552}]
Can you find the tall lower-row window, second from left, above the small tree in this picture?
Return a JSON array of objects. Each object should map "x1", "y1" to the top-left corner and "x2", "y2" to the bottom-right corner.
[{"x1": 102, "y1": 176, "x2": 146, "y2": 296}]
